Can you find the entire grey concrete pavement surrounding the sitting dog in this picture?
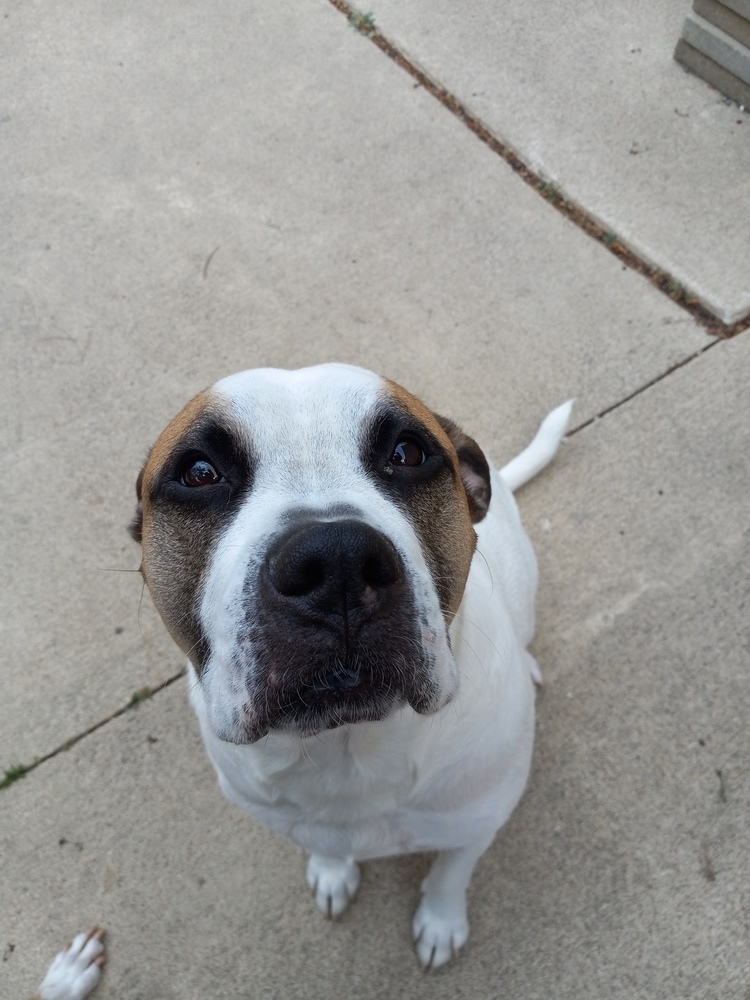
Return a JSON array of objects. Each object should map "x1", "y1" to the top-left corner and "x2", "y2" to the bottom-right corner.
[{"x1": 0, "y1": 0, "x2": 750, "y2": 1000}]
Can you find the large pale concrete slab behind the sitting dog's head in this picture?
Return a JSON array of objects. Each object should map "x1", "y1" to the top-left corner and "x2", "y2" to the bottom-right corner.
[{"x1": 0, "y1": 0, "x2": 709, "y2": 774}]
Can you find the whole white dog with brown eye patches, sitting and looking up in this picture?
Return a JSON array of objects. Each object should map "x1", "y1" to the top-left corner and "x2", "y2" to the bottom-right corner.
[{"x1": 131, "y1": 365, "x2": 571, "y2": 967}]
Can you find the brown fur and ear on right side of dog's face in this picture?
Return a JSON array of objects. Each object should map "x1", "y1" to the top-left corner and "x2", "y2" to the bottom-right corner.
[{"x1": 387, "y1": 380, "x2": 490, "y2": 621}]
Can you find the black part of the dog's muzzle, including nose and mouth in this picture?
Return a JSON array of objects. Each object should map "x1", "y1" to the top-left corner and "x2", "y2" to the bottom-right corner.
[{"x1": 241, "y1": 520, "x2": 434, "y2": 738}]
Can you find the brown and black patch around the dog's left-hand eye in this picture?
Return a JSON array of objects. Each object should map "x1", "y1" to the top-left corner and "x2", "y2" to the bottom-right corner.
[{"x1": 130, "y1": 389, "x2": 251, "y2": 670}]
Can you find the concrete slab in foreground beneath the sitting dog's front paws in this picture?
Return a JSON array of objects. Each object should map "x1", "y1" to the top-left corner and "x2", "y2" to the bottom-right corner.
[{"x1": 0, "y1": 334, "x2": 750, "y2": 1000}]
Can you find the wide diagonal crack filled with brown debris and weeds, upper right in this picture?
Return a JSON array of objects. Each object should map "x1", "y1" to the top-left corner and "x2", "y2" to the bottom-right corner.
[{"x1": 328, "y1": 0, "x2": 750, "y2": 339}]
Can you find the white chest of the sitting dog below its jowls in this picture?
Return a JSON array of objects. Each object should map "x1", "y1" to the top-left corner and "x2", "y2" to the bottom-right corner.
[{"x1": 196, "y1": 681, "x2": 533, "y2": 861}]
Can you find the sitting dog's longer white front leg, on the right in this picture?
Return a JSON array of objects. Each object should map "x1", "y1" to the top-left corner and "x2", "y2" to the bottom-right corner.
[{"x1": 412, "y1": 838, "x2": 493, "y2": 970}]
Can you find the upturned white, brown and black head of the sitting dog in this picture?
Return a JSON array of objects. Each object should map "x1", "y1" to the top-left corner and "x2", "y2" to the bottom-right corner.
[{"x1": 131, "y1": 365, "x2": 490, "y2": 743}]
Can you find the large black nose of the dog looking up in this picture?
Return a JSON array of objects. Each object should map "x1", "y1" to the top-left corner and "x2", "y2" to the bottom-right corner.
[{"x1": 267, "y1": 520, "x2": 403, "y2": 615}]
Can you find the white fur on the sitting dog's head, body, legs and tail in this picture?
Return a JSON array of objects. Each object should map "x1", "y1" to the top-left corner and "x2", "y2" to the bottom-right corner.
[{"x1": 131, "y1": 366, "x2": 572, "y2": 968}]
